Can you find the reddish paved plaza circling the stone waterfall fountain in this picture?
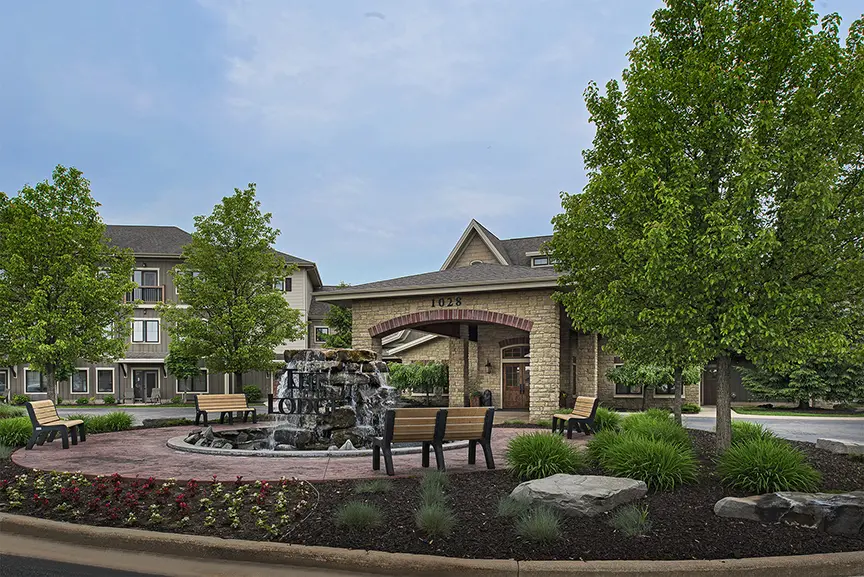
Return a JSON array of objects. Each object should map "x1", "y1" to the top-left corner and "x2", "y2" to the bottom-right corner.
[{"x1": 12, "y1": 425, "x2": 585, "y2": 481}]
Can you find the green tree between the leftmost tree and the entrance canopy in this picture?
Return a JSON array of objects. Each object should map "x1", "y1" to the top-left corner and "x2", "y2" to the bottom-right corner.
[{"x1": 160, "y1": 184, "x2": 305, "y2": 392}]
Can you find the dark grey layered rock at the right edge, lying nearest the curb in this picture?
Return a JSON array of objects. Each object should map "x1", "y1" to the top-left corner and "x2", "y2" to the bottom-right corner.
[{"x1": 714, "y1": 491, "x2": 864, "y2": 539}]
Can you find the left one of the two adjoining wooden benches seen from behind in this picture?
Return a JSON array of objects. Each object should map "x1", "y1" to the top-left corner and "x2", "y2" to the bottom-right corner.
[{"x1": 372, "y1": 409, "x2": 446, "y2": 476}]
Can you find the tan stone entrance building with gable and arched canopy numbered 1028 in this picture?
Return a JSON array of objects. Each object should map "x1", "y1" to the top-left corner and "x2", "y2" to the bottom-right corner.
[{"x1": 315, "y1": 221, "x2": 699, "y2": 421}]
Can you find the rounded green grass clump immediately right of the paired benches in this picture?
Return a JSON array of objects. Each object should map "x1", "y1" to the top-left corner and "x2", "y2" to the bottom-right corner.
[{"x1": 506, "y1": 433, "x2": 584, "y2": 479}]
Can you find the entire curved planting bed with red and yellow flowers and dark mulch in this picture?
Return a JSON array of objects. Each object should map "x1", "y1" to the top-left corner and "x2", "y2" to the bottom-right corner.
[{"x1": 0, "y1": 431, "x2": 864, "y2": 560}]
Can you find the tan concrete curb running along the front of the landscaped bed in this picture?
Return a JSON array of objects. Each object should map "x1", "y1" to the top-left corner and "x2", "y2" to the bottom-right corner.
[{"x1": 0, "y1": 513, "x2": 864, "y2": 577}]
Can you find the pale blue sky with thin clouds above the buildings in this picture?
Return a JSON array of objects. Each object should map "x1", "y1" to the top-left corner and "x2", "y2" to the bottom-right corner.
[{"x1": 0, "y1": 0, "x2": 864, "y2": 284}]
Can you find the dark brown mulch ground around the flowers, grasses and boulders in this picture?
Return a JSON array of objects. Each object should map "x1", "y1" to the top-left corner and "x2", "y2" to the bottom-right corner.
[{"x1": 0, "y1": 431, "x2": 864, "y2": 560}]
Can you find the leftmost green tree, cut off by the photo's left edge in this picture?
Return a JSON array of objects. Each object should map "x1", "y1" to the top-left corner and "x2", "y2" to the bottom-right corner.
[{"x1": 0, "y1": 165, "x2": 135, "y2": 401}]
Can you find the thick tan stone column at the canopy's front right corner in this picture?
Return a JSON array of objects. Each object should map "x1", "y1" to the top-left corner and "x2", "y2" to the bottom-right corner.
[{"x1": 529, "y1": 307, "x2": 561, "y2": 423}]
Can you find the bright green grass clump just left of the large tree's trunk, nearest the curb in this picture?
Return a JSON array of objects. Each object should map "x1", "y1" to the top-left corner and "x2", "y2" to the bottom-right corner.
[{"x1": 602, "y1": 433, "x2": 696, "y2": 491}]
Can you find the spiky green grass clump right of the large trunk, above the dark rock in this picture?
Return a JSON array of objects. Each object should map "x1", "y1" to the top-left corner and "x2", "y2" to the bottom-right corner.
[{"x1": 717, "y1": 439, "x2": 822, "y2": 494}]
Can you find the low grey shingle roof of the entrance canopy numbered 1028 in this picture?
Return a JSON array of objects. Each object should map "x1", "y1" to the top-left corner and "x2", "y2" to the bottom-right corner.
[{"x1": 327, "y1": 264, "x2": 558, "y2": 294}]
